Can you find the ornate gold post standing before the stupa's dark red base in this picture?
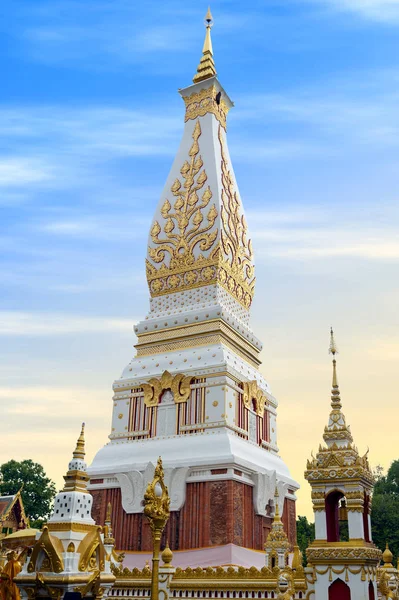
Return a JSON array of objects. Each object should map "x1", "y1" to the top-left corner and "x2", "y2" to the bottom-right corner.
[{"x1": 144, "y1": 457, "x2": 170, "y2": 600}]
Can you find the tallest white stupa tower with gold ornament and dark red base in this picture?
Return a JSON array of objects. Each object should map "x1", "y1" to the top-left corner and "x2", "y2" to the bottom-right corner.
[{"x1": 89, "y1": 11, "x2": 298, "y2": 562}]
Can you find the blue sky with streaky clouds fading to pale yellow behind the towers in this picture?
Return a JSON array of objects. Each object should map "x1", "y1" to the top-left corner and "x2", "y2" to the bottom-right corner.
[{"x1": 0, "y1": 0, "x2": 399, "y2": 513}]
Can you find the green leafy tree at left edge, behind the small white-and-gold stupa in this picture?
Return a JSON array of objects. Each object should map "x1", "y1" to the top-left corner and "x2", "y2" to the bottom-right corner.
[{"x1": 0, "y1": 459, "x2": 56, "y2": 526}]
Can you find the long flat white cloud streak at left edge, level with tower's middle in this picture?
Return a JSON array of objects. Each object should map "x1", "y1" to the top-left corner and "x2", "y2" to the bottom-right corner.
[{"x1": 0, "y1": 310, "x2": 136, "y2": 336}]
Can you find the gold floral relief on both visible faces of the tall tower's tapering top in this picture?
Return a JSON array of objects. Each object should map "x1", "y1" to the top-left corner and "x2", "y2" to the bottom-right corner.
[{"x1": 146, "y1": 113, "x2": 255, "y2": 309}]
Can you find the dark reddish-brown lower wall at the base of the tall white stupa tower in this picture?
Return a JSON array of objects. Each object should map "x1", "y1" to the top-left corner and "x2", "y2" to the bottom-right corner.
[{"x1": 91, "y1": 480, "x2": 296, "y2": 551}]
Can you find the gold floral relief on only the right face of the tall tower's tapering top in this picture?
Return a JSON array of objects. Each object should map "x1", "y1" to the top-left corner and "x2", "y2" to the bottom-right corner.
[{"x1": 219, "y1": 126, "x2": 255, "y2": 308}]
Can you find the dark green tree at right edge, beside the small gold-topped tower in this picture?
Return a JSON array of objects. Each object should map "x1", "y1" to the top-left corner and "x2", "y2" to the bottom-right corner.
[{"x1": 371, "y1": 460, "x2": 399, "y2": 558}]
